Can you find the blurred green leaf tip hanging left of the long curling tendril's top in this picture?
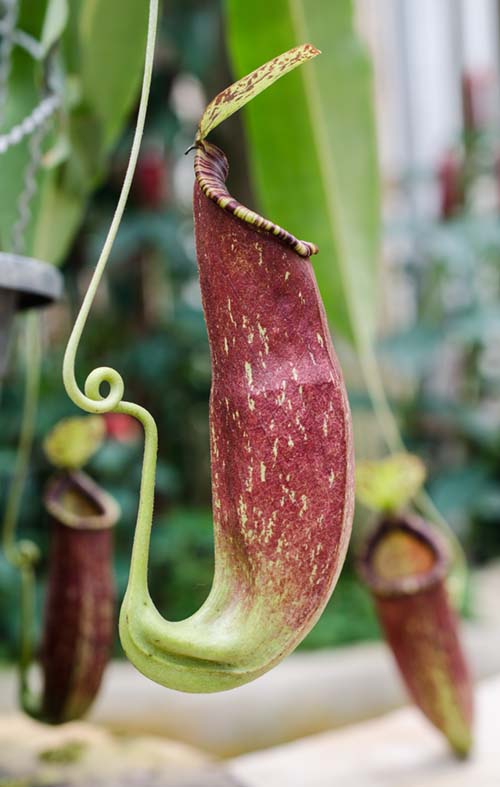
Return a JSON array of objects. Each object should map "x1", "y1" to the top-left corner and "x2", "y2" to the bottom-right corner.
[{"x1": 80, "y1": 0, "x2": 149, "y2": 147}]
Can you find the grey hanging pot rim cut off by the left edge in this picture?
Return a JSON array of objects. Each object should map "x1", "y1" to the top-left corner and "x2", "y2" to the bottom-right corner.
[{"x1": 0, "y1": 251, "x2": 63, "y2": 311}]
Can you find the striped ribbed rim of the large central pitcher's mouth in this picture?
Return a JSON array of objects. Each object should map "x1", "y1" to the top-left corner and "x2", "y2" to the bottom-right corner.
[{"x1": 194, "y1": 140, "x2": 318, "y2": 257}]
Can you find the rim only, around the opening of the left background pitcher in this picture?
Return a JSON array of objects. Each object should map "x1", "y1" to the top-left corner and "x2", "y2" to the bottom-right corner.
[{"x1": 43, "y1": 470, "x2": 120, "y2": 530}]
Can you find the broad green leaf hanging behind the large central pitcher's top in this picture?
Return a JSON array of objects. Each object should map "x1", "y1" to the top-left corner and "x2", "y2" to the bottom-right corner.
[{"x1": 226, "y1": 0, "x2": 380, "y2": 347}]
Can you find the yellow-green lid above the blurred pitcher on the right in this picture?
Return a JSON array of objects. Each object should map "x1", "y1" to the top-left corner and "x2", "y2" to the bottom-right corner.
[{"x1": 356, "y1": 454, "x2": 426, "y2": 513}]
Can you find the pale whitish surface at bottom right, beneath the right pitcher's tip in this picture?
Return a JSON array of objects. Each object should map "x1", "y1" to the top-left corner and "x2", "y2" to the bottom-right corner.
[{"x1": 229, "y1": 676, "x2": 500, "y2": 787}]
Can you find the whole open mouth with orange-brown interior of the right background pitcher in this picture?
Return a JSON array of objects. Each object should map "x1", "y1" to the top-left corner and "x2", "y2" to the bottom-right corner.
[{"x1": 358, "y1": 514, "x2": 450, "y2": 598}]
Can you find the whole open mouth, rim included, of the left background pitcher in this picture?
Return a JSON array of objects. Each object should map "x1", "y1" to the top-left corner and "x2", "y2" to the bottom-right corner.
[{"x1": 44, "y1": 471, "x2": 120, "y2": 530}]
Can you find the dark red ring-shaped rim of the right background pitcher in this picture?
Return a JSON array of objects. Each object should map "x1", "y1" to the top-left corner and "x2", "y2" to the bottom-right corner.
[{"x1": 358, "y1": 514, "x2": 450, "y2": 598}]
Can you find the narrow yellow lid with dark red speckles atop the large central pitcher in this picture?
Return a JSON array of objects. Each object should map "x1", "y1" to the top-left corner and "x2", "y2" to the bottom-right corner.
[{"x1": 196, "y1": 44, "x2": 320, "y2": 140}]
